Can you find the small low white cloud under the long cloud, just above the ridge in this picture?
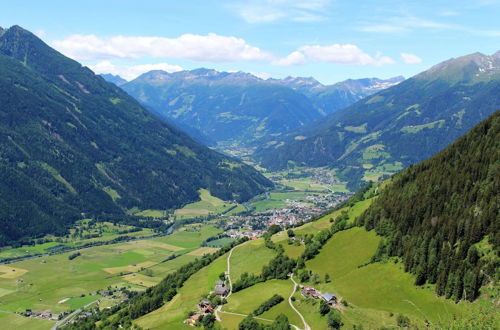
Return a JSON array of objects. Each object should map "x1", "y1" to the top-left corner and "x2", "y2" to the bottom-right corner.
[{"x1": 89, "y1": 61, "x2": 182, "y2": 81}]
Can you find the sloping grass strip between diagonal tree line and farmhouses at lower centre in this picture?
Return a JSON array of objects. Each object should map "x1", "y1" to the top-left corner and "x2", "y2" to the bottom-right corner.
[{"x1": 135, "y1": 254, "x2": 227, "y2": 329}]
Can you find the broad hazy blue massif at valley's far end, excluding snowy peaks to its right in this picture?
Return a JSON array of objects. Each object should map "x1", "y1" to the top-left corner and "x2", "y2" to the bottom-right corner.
[{"x1": 121, "y1": 69, "x2": 321, "y2": 144}]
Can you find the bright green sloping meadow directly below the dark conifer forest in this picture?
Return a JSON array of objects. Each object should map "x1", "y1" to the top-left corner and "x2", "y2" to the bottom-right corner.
[{"x1": 306, "y1": 228, "x2": 468, "y2": 326}]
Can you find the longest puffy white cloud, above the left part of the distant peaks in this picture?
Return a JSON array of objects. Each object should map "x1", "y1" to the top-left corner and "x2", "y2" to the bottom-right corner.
[{"x1": 52, "y1": 33, "x2": 272, "y2": 62}]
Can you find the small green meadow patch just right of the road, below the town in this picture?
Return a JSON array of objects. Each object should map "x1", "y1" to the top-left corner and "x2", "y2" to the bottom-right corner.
[{"x1": 231, "y1": 239, "x2": 275, "y2": 281}]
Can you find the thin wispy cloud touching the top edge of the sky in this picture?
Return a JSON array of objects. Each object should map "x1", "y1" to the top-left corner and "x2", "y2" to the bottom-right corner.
[{"x1": 232, "y1": 0, "x2": 331, "y2": 23}]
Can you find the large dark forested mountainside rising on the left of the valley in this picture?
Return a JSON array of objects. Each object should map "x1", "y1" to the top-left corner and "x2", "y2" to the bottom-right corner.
[{"x1": 0, "y1": 26, "x2": 271, "y2": 245}]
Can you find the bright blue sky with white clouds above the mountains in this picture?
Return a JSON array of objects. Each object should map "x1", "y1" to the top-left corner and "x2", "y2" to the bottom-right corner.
[{"x1": 0, "y1": 0, "x2": 500, "y2": 84}]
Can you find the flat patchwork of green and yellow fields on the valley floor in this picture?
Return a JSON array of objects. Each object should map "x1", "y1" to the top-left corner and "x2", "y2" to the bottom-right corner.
[{"x1": 0, "y1": 225, "x2": 220, "y2": 329}]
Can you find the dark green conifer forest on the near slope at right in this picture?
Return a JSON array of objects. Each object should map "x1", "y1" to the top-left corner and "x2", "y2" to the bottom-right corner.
[{"x1": 357, "y1": 111, "x2": 500, "y2": 300}]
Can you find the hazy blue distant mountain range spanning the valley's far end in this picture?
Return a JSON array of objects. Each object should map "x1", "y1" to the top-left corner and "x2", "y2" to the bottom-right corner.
[{"x1": 111, "y1": 69, "x2": 403, "y2": 146}]
